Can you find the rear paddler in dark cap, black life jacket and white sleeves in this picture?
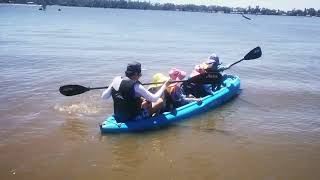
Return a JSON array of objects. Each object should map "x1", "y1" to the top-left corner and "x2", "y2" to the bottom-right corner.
[{"x1": 101, "y1": 62, "x2": 169, "y2": 122}]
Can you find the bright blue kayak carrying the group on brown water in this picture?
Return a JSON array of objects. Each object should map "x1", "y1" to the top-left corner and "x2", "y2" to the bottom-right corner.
[{"x1": 100, "y1": 75, "x2": 240, "y2": 133}]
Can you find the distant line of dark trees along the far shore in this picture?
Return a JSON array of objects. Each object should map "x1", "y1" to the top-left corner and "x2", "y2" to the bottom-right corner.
[{"x1": 0, "y1": 0, "x2": 320, "y2": 17}]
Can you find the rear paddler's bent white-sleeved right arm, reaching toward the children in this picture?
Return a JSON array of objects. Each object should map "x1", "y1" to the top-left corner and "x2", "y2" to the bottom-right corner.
[{"x1": 134, "y1": 83, "x2": 167, "y2": 102}]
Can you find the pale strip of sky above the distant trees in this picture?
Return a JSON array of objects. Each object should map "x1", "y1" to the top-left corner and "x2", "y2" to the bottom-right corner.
[{"x1": 150, "y1": 0, "x2": 320, "y2": 10}]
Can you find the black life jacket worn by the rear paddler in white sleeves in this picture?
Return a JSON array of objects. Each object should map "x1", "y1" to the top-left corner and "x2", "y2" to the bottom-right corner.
[{"x1": 111, "y1": 79, "x2": 142, "y2": 122}]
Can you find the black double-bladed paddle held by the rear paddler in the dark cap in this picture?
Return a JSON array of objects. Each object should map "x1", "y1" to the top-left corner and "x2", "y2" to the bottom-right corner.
[{"x1": 59, "y1": 75, "x2": 215, "y2": 96}]
